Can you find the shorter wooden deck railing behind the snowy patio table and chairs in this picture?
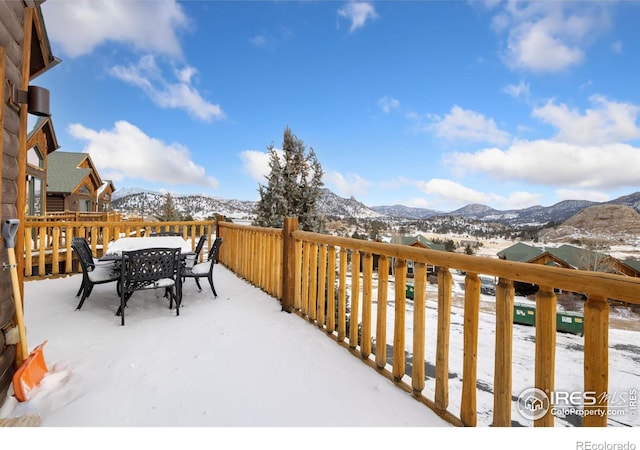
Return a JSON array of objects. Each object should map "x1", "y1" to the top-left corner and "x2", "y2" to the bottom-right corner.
[{"x1": 24, "y1": 217, "x2": 215, "y2": 278}]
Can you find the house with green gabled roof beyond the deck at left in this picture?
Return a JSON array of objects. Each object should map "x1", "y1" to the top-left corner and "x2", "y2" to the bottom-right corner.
[{"x1": 47, "y1": 151, "x2": 115, "y2": 213}]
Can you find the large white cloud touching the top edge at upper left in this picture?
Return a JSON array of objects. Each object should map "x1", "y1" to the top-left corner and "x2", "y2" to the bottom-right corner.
[{"x1": 42, "y1": 0, "x2": 189, "y2": 58}]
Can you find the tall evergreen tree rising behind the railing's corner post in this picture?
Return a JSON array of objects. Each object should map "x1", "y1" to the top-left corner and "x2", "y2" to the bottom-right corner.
[{"x1": 254, "y1": 127, "x2": 324, "y2": 231}]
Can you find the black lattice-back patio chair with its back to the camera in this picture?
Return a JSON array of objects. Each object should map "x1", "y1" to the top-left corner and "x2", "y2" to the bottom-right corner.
[{"x1": 116, "y1": 248, "x2": 182, "y2": 325}]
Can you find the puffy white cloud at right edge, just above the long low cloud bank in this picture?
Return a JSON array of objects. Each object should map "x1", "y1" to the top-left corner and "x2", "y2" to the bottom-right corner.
[{"x1": 533, "y1": 96, "x2": 640, "y2": 145}]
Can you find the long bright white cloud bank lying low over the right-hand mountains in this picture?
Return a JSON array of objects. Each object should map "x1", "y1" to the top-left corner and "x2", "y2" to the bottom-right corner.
[{"x1": 447, "y1": 140, "x2": 640, "y2": 189}]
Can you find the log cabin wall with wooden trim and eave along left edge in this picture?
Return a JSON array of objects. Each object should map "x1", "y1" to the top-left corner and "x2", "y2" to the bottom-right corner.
[{"x1": 0, "y1": 0, "x2": 60, "y2": 404}]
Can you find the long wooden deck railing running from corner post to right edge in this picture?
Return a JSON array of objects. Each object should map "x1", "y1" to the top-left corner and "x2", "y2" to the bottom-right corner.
[{"x1": 217, "y1": 219, "x2": 640, "y2": 427}]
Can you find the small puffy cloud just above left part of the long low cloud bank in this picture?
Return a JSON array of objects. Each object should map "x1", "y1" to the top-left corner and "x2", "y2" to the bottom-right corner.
[{"x1": 429, "y1": 105, "x2": 510, "y2": 144}]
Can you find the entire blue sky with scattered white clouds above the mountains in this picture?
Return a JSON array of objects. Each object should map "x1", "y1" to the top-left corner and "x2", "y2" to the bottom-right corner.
[{"x1": 37, "y1": 0, "x2": 640, "y2": 211}]
